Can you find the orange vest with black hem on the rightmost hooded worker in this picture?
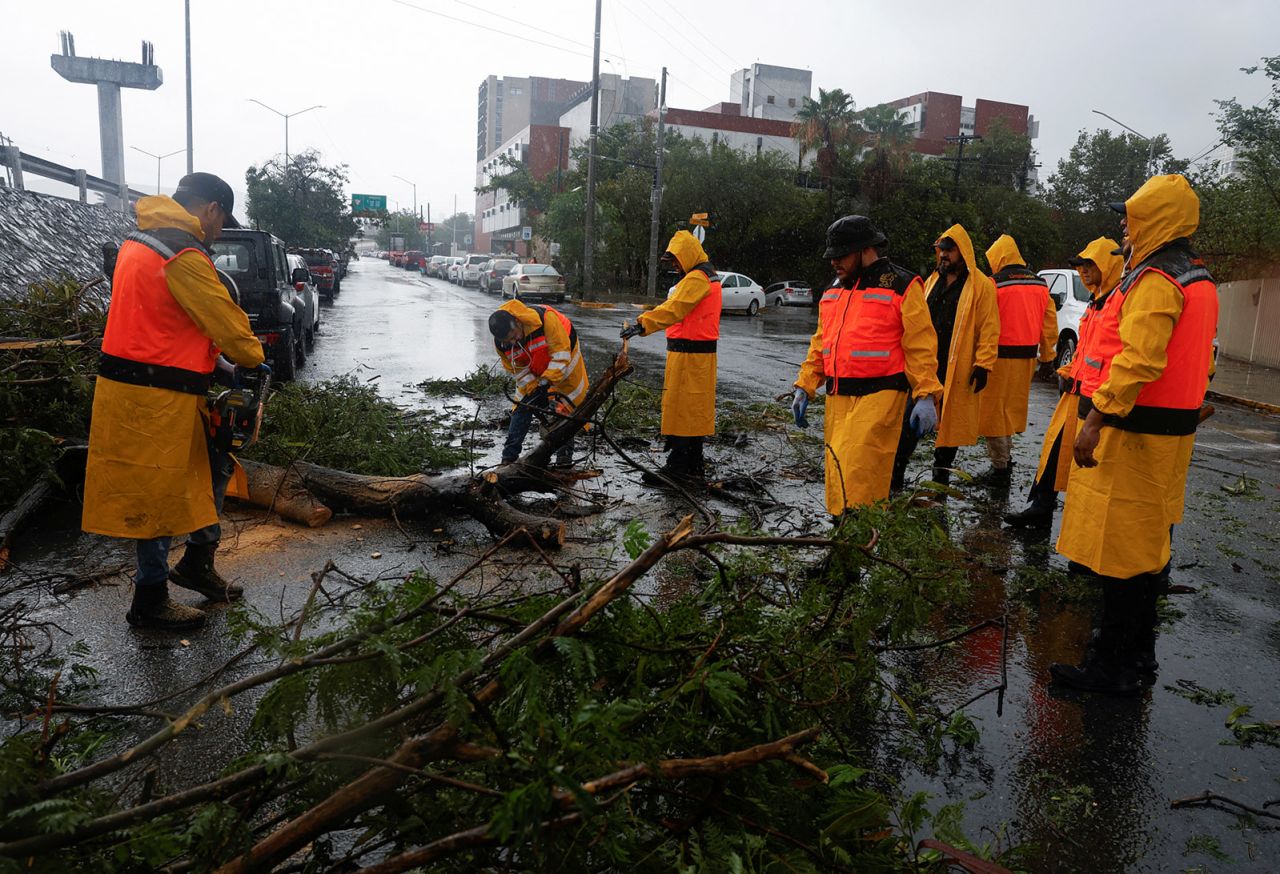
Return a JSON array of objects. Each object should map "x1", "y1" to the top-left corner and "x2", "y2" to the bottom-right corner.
[{"x1": 1080, "y1": 241, "x2": 1217, "y2": 436}]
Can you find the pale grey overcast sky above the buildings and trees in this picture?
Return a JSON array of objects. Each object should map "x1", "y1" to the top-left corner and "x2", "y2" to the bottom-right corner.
[{"x1": 0, "y1": 0, "x2": 1280, "y2": 220}]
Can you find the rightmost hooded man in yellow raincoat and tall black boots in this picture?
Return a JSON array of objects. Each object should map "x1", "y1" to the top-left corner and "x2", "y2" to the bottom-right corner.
[{"x1": 1050, "y1": 174, "x2": 1217, "y2": 694}]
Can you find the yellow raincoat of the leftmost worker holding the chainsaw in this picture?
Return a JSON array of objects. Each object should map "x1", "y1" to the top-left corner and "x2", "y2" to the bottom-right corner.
[{"x1": 81, "y1": 197, "x2": 264, "y2": 540}]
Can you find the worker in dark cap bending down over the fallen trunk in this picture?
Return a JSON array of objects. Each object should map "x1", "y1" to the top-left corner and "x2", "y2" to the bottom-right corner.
[{"x1": 489, "y1": 301, "x2": 588, "y2": 467}]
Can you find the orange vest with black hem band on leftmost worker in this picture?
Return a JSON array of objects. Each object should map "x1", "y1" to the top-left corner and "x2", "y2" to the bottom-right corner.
[{"x1": 99, "y1": 228, "x2": 218, "y2": 394}]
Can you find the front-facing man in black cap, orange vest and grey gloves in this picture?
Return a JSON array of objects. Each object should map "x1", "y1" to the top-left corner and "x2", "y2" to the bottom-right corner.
[{"x1": 791, "y1": 215, "x2": 942, "y2": 516}]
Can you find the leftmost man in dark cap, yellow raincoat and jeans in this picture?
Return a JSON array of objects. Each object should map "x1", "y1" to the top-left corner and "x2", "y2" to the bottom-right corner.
[{"x1": 81, "y1": 173, "x2": 265, "y2": 628}]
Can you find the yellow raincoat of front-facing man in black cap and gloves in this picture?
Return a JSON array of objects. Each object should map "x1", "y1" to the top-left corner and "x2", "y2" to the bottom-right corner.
[{"x1": 795, "y1": 266, "x2": 942, "y2": 516}]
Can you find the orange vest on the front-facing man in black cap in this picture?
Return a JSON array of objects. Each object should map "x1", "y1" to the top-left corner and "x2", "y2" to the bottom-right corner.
[{"x1": 818, "y1": 258, "x2": 920, "y2": 395}]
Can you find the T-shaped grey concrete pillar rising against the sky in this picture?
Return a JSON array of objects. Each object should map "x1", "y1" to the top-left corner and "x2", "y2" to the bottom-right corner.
[{"x1": 49, "y1": 31, "x2": 164, "y2": 209}]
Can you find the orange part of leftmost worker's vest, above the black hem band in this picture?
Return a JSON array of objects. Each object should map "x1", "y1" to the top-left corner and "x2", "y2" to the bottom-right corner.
[{"x1": 102, "y1": 233, "x2": 220, "y2": 374}]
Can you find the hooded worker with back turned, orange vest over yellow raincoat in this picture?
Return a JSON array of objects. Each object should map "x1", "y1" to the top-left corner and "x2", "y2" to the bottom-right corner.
[{"x1": 978, "y1": 234, "x2": 1057, "y2": 489}]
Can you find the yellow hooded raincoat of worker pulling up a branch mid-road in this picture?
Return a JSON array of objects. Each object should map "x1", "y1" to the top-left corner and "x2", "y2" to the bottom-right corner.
[{"x1": 636, "y1": 230, "x2": 717, "y2": 436}]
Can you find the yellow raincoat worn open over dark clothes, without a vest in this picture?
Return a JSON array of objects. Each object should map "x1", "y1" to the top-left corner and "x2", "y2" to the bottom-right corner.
[{"x1": 924, "y1": 224, "x2": 1000, "y2": 447}]
